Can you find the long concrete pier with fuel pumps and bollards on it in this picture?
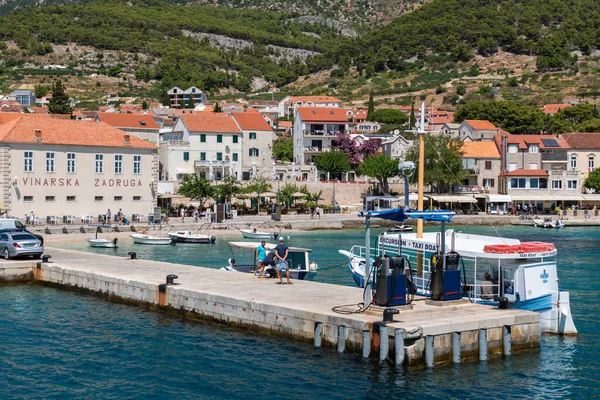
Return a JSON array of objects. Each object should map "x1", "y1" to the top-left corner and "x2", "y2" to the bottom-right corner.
[{"x1": 0, "y1": 247, "x2": 541, "y2": 366}]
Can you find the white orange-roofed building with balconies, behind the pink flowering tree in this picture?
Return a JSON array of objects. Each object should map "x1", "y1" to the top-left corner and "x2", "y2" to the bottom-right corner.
[{"x1": 294, "y1": 107, "x2": 348, "y2": 165}]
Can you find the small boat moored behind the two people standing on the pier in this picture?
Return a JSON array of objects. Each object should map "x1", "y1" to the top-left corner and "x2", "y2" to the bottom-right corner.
[{"x1": 221, "y1": 242, "x2": 318, "y2": 280}]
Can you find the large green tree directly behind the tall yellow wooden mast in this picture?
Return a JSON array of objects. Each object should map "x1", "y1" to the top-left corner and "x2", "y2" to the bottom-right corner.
[{"x1": 405, "y1": 135, "x2": 466, "y2": 193}]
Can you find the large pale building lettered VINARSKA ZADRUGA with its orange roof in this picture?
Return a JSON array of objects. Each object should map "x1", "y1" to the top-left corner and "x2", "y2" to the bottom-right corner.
[{"x1": 0, "y1": 116, "x2": 158, "y2": 222}]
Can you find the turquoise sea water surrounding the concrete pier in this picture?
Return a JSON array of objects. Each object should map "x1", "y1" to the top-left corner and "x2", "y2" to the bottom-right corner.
[{"x1": 0, "y1": 227, "x2": 600, "y2": 399}]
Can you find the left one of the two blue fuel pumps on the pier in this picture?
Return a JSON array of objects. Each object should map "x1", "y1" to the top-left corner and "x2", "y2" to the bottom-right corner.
[{"x1": 375, "y1": 256, "x2": 408, "y2": 307}]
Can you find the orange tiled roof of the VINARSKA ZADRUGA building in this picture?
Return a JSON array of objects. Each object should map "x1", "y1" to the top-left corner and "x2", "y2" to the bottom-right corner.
[{"x1": 0, "y1": 116, "x2": 157, "y2": 149}]
